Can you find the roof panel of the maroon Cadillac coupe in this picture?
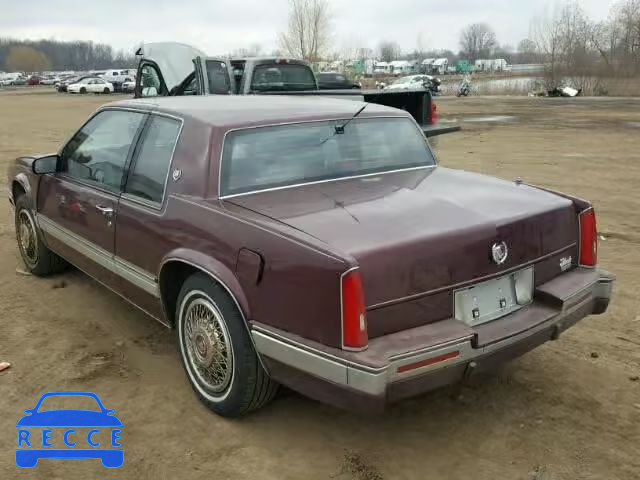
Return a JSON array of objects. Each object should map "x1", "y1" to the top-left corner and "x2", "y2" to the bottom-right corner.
[{"x1": 107, "y1": 94, "x2": 409, "y2": 127}]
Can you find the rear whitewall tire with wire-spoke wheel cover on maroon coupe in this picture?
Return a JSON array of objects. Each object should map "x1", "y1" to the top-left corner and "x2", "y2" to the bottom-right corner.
[{"x1": 175, "y1": 273, "x2": 278, "y2": 417}]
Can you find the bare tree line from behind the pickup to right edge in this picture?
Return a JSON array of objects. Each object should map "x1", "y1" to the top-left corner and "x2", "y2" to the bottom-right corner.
[{"x1": 279, "y1": 0, "x2": 640, "y2": 77}]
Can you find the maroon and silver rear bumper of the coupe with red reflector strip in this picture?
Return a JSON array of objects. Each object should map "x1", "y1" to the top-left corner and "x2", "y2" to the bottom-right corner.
[{"x1": 252, "y1": 268, "x2": 614, "y2": 411}]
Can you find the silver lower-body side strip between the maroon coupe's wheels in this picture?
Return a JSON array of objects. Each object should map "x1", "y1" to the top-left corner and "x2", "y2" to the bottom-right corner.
[{"x1": 36, "y1": 214, "x2": 160, "y2": 298}]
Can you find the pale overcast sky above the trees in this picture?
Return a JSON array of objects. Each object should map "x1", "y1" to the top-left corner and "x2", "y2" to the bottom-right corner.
[{"x1": 0, "y1": 0, "x2": 614, "y2": 54}]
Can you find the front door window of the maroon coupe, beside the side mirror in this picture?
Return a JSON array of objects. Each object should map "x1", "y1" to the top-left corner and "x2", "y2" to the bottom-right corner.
[{"x1": 60, "y1": 110, "x2": 144, "y2": 193}]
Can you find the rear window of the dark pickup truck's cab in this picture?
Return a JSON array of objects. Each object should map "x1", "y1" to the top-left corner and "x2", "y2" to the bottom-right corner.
[{"x1": 251, "y1": 64, "x2": 316, "y2": 92}]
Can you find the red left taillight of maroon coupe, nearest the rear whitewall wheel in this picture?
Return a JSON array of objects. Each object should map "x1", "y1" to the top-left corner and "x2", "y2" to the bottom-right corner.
[{"x1": 340, "y1": 270, "x2": 369, "y2": 350}]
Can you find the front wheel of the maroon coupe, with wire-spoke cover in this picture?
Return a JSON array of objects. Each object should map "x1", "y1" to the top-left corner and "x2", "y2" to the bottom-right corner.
[{"x1": 15, "y1": 194, "x2": 68, "y2": 277}]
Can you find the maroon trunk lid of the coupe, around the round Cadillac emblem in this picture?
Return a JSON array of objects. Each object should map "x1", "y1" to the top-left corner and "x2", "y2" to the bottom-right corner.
[{"x1": 228, "y1": 167, "x2": 578, "y2": 336}]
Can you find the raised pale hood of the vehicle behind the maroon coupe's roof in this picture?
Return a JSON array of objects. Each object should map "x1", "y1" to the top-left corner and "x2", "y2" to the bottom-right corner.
[{"x1": 142, "y1": 42, "x2": 206, "y2": 91}]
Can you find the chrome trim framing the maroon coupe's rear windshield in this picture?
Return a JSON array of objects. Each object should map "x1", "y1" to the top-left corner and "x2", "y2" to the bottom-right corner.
[{"x1": 217, "y1": 115, "x2": 438, "y2": 200}]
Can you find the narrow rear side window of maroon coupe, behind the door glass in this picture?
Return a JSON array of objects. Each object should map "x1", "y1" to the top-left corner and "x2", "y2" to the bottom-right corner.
[{"x1": 125, "y1": 115, "x2": 182, "y2": 204}]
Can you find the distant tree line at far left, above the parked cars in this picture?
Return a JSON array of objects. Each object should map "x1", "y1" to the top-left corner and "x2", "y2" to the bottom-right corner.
[{"x1": 0, "y1": 38, "x2": 137, "y2": 72}]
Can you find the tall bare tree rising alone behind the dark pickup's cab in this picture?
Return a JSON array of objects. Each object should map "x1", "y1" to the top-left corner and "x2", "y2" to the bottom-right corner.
[{"x1": 280, "y1": 0, "x2": 331, "y2": 62}]
